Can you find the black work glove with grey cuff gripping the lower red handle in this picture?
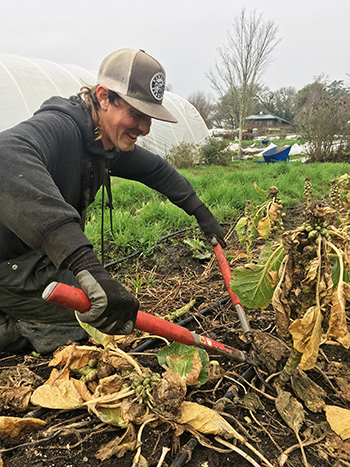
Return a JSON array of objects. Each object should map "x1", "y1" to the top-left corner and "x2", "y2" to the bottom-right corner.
[{"x1": 65, "y1": 247, "x2": 139, "y2": 335}]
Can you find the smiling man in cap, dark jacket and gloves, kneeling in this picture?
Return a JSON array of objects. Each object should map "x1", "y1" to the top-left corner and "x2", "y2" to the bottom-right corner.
[{"x1": 0, "y1": 49, "x2": 224, "y2": 353}]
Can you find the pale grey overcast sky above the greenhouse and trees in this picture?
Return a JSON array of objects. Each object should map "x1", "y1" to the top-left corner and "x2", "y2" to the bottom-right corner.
[{"x1": 0, "y1": 0, "x2": 350, "y2": 98}]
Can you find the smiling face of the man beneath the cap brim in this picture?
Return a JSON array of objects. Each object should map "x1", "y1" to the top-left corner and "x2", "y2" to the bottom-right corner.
[{"x1": 99, "y1": 88, "x2": 152, "y2": 151}]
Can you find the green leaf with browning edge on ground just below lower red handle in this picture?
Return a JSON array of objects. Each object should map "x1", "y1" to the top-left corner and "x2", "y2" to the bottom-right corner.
[{"x1": 157, "y1": 342, "x2": 209, "y2": 384}]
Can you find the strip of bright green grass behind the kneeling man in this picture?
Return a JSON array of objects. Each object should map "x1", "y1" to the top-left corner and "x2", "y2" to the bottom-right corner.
[{"x1": 85, "y1": 161, "x2": 350, "y2": 261}]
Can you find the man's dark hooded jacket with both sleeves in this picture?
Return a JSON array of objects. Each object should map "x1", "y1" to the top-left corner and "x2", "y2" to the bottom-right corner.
[{"x1": 0, "y1": 96, "x2": 203, "y2": 267}]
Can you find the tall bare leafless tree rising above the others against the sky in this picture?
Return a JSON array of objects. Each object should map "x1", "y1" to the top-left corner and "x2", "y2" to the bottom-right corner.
[{"x1": 208, "y1": 8, "x2": 279, "y2": 156}]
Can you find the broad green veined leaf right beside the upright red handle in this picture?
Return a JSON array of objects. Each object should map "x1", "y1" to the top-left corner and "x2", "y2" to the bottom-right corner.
[{"x1": 230, "y1": 246, "x2": 284, "y2": 308}]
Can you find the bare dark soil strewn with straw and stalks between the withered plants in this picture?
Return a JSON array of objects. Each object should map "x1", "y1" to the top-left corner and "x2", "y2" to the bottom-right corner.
[{"x1": 0, "y1": 208, "x2": 350, "y2": 467}]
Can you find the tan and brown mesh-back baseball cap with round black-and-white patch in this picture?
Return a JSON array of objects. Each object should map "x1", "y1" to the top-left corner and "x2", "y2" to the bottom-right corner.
[{"x1": 97, "y1": 49, "x2": 177, "y2": 123}]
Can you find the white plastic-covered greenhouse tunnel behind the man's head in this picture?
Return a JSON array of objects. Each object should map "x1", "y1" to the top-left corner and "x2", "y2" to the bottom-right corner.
[{"x1": 0, "y1": 53, "x2": 209, "y2": 157}]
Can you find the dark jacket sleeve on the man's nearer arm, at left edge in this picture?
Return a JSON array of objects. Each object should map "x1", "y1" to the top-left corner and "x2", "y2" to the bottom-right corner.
[{"x1": 0, "y1": 116, "x2": 91, "y2": 267}]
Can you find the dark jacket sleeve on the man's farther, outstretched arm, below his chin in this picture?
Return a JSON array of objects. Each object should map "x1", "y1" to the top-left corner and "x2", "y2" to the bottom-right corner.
[{"x1": 111, "y1": 145, "x2": 203, "y2": 215}]
